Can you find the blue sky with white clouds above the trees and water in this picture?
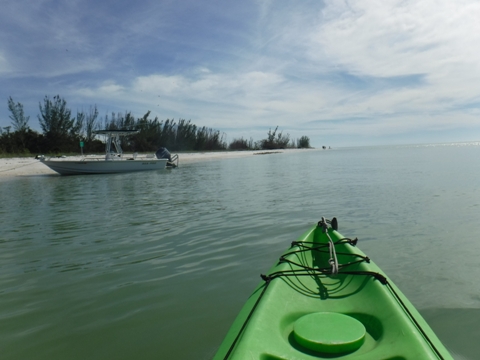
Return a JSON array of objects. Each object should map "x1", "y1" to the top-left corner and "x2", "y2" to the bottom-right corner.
[{"x1": 0, "y1": 0, "x2": 480, "y2": 147}]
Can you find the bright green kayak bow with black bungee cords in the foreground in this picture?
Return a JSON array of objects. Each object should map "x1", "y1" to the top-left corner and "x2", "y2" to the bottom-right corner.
[{"x1": 214, "y1": 218, "x2": 452, "y2": 360}]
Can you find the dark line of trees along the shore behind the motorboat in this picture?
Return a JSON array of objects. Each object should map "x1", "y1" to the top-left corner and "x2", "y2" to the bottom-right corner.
[{"x1": 0, "y1": 95, "x2": 310, "y2": 154}]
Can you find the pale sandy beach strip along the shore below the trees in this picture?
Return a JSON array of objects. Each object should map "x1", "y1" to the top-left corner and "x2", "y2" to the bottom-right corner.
[{"x1": 0, "y1": 149, "x2": 318, "y2": 178}]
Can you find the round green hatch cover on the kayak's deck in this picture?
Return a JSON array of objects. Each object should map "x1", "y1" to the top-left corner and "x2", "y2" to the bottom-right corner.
[{"x1": 293, "y1": 312, "x2": 366, "y2": 354}]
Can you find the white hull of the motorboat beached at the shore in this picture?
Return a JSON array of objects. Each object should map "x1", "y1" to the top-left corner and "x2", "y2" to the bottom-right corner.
[{"x1": 42, "y1": 159, "x2": 168, "y2": 175}]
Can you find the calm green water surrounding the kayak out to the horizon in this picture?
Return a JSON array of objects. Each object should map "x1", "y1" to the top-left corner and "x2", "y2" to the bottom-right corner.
[{"x1": 0, "y1": 144, "x2": 480, "y2": 359}]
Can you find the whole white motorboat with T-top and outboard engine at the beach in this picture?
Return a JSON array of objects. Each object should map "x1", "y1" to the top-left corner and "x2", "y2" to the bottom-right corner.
[{"x1": 40, "y1": 130, "x2": 178, "y2": 175}]
